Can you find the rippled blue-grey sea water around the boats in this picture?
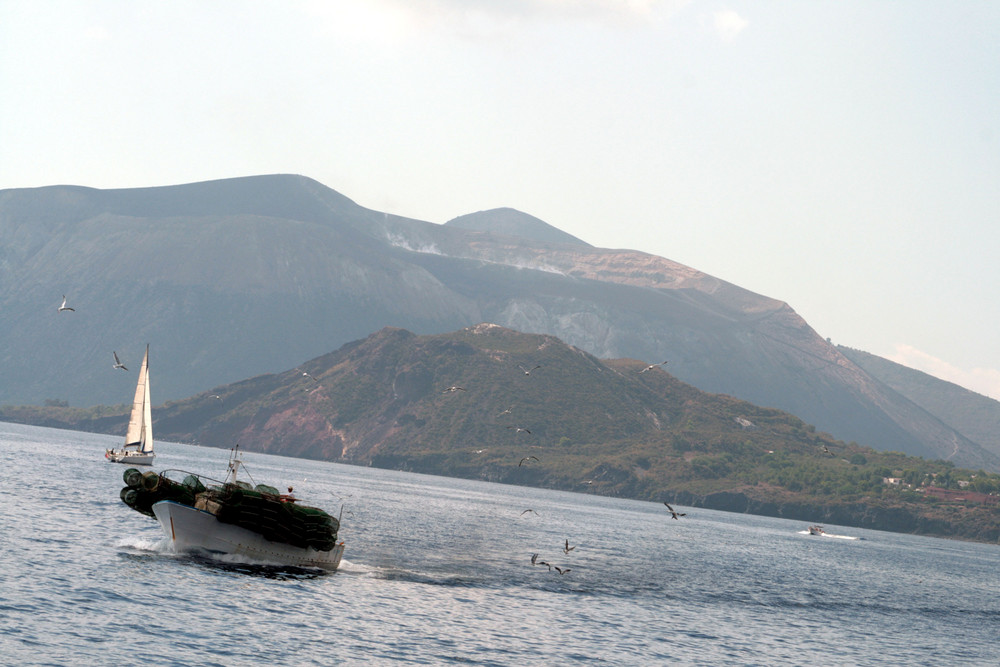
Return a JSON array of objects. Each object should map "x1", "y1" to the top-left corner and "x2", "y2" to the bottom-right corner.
[{"x1": 0, "y1": 423, "x2": 1000, "y2": 666}]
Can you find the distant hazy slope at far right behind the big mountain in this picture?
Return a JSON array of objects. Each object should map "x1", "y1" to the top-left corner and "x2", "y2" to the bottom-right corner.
[{"x1": 837, "y1": 346, "x2": 1000, "y2": 462}]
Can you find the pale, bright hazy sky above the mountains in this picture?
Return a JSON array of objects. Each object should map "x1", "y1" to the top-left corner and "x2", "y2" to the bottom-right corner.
[{"x1": 0, "y1": 0, "x2": 1000, "y2": 399}]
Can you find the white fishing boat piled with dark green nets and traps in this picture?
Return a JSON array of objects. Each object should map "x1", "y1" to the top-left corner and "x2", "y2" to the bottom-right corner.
[{"x1": 121, "y1": 448, "x2": 344, "y2": 571}]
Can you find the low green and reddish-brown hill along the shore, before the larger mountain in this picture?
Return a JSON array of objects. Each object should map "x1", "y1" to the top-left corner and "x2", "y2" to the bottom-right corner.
[{"x1": 0, "y1": 324, "x2": 1000, "y2": 541}]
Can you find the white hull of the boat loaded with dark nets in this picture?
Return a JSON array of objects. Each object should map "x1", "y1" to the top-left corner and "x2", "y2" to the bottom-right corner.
[{"x1": 153, "y1": 500, "x2": 344, "y2": 570}]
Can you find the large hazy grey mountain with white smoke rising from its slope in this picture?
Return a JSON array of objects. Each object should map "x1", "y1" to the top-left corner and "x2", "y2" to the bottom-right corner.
[{"x1": 0, "y1": 175, "x2": 1000, "y2": 469}]
